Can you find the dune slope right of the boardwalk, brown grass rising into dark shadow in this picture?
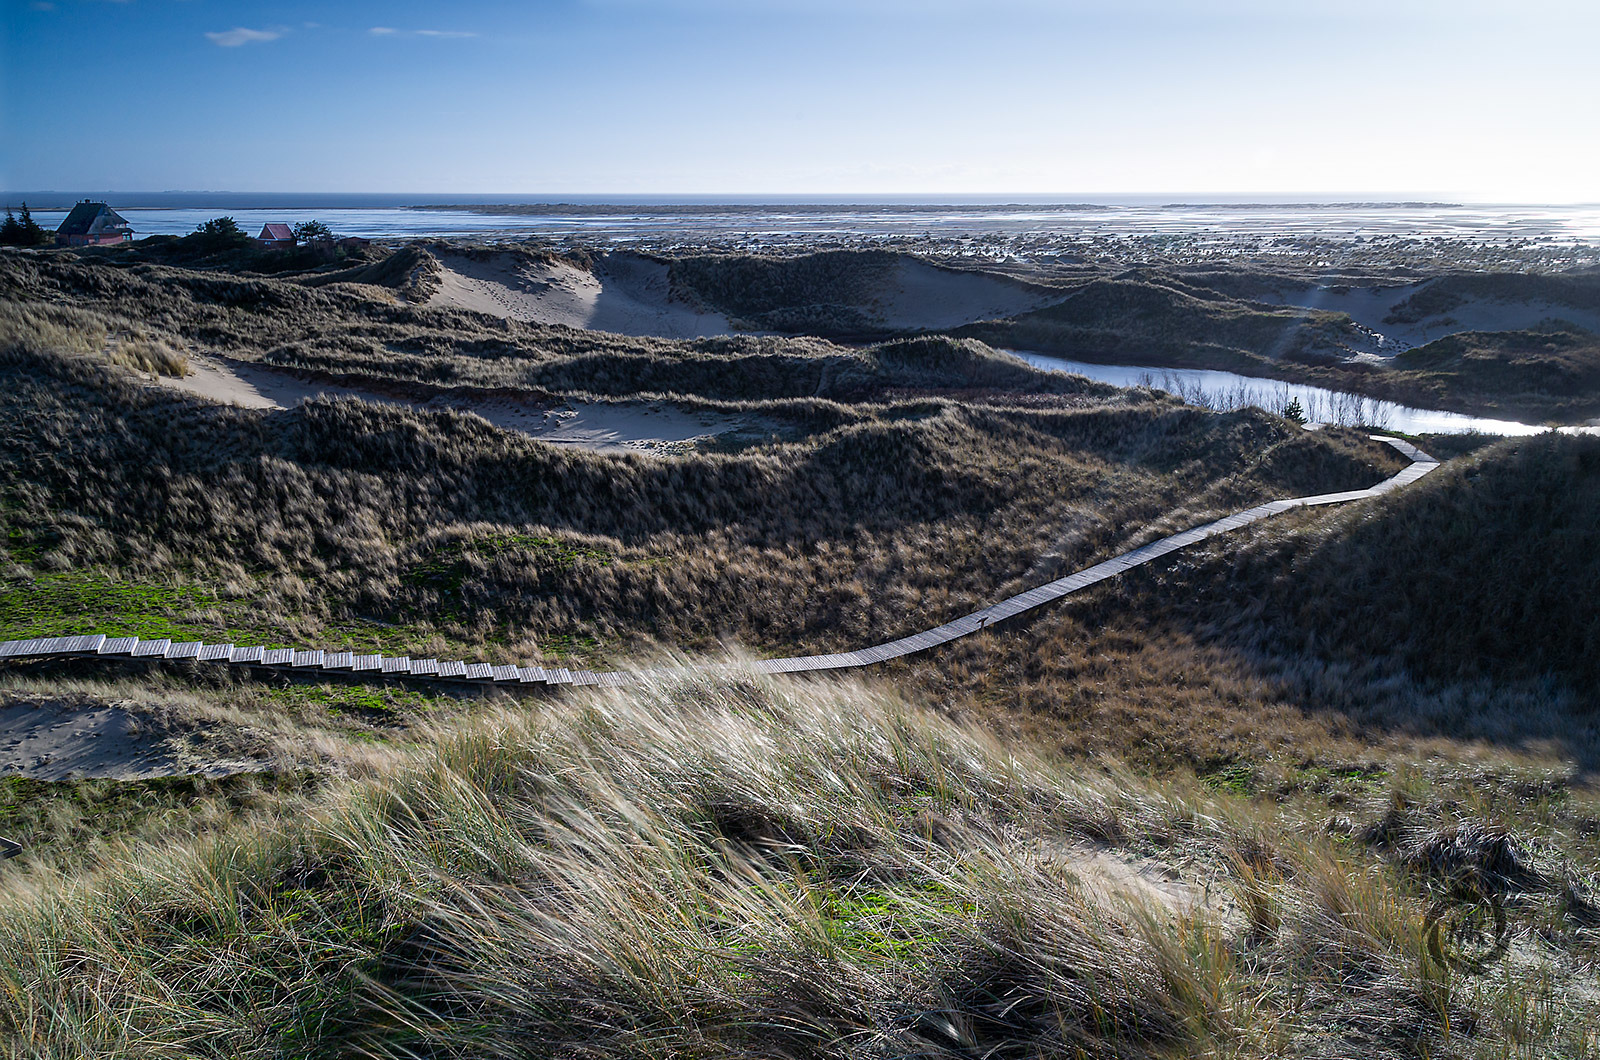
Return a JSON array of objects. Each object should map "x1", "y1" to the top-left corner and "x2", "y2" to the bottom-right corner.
[{"x1": 907, "y1": 434, "x2": 1600, "y2": 788}]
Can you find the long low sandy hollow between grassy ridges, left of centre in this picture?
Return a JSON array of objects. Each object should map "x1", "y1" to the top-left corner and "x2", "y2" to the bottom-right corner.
[{"x1": 150, "y1": 355, "x2": 779, "y2": 453}]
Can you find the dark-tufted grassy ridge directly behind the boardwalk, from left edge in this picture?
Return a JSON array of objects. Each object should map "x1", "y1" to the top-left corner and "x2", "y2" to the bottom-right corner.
[{"x1": 0, "y1": 347, "x2": 1397, "y2": 669}]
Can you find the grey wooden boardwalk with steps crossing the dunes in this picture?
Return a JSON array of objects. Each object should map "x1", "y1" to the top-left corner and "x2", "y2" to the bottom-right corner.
[{"x1": 0, "y1": 434, "x2": 1438, "y2": 685}]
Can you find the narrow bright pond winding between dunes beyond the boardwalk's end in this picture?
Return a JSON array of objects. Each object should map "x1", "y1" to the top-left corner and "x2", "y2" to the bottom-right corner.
[{"x1": 1008, "y1": 349, "x2": 1544, "y2": 436}]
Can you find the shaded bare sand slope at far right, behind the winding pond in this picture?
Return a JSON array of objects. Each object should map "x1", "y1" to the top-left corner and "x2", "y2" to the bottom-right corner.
[{"x1": 1259, "y1": 280, "x2": 1600, "y2": 355}]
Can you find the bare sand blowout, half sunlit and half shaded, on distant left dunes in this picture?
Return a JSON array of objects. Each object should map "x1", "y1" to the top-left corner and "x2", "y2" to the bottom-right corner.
[{"x1": 427, "y1": 253, "x2": 731, "y2": 338}]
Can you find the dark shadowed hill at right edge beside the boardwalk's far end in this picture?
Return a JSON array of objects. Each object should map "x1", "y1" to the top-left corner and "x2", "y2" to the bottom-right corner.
[{"x1": 1190, "y1": 434, "x2": 1600, "y2": 689}]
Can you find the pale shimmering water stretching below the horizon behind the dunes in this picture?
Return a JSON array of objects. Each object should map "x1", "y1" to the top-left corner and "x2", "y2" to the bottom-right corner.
[{"x1": 18, "y1": 192, "x2": 1600, "y2": 245}]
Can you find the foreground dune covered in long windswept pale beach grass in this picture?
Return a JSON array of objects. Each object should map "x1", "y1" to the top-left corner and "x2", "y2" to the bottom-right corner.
[{"x1": 0, "y1": 681, "x2": 1597, "y2": 1058}]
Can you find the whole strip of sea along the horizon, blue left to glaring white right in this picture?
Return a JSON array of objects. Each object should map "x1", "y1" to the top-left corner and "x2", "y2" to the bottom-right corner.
[{"x1": 12, "y1": 192, "x2": 1600, "y2": 247}]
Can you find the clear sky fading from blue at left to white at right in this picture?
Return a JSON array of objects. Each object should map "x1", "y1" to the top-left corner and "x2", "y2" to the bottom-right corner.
[{"x1": 0, "y1": 0, "x2": 1600, "y2": 203}]
